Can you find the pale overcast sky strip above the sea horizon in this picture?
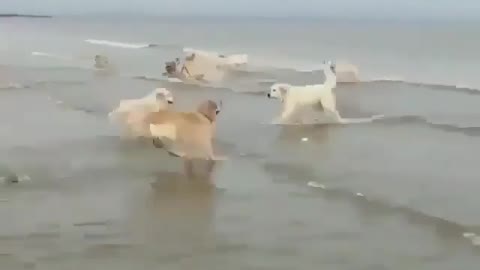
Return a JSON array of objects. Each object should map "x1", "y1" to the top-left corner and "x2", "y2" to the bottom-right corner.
[{"x1": 0, "y1": 0, "x2": 480, "y2": 18}]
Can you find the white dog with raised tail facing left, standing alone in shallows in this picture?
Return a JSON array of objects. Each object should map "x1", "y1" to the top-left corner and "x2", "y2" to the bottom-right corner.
[{"x1": 267, "y1": 62, "x2": 340, "y2": 123}]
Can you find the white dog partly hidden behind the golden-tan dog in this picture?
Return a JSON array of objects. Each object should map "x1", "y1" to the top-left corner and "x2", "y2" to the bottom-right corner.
[{"x1": 108, "y1": 88, "x2": 174, "y2": 137}]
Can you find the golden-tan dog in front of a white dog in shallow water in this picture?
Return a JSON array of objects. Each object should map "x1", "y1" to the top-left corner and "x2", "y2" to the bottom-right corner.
[{"x1": 145, "y1": 100, "x2": 224, "y2": 177}]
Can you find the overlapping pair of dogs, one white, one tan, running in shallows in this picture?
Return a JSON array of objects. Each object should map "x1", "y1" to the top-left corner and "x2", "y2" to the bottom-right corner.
[{"x1": 109, "y1": 88, "x2": 222, "y2": 177}]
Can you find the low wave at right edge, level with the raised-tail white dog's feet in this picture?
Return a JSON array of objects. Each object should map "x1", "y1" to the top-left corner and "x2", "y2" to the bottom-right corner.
[{"x1": 377, "y1": 115, "x2": 480, "y2": 137}]
